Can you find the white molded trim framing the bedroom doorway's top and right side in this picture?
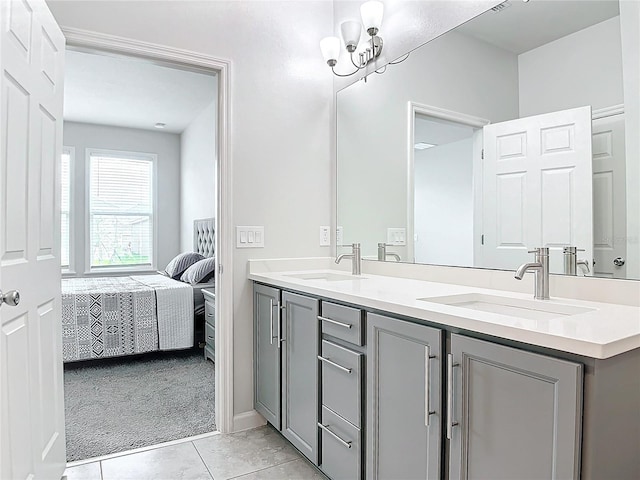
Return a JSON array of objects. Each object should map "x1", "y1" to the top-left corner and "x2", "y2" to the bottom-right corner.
[{"x1": 62, "y1": 27, "x2": 236, "y2": 433}]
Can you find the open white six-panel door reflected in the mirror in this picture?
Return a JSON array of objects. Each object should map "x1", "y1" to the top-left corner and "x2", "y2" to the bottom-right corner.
[{"x1": 481, "y1": 107, "x2": 593, "y2": 273}]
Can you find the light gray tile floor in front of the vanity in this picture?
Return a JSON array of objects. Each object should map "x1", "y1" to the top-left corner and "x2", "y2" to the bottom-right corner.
[{"x1": 63, "y1": 425, "x2": 326, "y2": 480}]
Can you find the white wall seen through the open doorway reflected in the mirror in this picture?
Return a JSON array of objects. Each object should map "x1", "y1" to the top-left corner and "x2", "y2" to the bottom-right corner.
[{"x1": 414, "y1": 137, "x2": 473, "y2": 267}]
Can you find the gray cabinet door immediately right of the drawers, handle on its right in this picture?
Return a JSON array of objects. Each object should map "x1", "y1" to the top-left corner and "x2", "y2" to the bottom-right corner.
[{"x1": 366, "y1": 314, "x2": 442, "y2": 480}]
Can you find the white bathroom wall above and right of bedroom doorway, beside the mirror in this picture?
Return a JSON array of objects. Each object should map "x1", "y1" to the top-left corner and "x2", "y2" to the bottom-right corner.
[{"x1": 49, "y1": 1, "x2": 333, "y2": 424}]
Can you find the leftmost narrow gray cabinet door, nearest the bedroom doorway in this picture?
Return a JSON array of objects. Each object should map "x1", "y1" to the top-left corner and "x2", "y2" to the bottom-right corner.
[{"x1": 253, "y1": 284, "x2": 280, "y2": 430}]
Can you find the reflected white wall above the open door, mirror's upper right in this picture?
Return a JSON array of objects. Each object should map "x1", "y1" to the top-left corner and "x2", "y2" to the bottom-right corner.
[{"x1": 518, "y1": 17, "x2": 624, "y2": 117}]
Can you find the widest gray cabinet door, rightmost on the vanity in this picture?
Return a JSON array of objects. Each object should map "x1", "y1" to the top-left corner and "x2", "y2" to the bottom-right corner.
[{"x1": 447, "y1": 334, "x2": 582, "y2": 480}]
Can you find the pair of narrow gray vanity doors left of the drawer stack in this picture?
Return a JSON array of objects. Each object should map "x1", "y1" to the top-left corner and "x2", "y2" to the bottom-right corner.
[{"x1": 253, "y1": 284, "x2": 319, "y2": 465}]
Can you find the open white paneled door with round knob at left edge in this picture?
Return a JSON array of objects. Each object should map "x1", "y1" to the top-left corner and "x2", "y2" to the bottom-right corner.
[{"x1": 0, "y1": 0, "x2": 66, "y2": 480}]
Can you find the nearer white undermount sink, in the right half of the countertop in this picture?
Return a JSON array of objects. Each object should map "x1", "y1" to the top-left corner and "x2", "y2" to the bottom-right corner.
[{"x1": 418, "y1": 293, "x2": 594, "y2": 320}]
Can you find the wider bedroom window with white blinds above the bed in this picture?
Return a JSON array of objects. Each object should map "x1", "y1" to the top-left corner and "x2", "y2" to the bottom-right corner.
[{"x1": 88, "y1": 150, "x2": 156, "y2": 270}]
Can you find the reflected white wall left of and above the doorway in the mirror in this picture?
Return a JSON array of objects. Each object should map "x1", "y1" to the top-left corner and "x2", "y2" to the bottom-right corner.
[{"x1": 337, "y1": 32, "x2": 518, "y2": 259}]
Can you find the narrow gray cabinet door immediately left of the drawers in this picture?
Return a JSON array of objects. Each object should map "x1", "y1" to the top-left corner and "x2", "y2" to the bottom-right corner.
[{"x1": 282, "y1": 292, "x2": 319, "y2": 465}]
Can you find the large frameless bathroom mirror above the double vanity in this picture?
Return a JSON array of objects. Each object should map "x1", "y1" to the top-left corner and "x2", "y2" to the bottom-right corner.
[{"x1": 337, "y1": 0, "x2": 640, "y2": 279}]
